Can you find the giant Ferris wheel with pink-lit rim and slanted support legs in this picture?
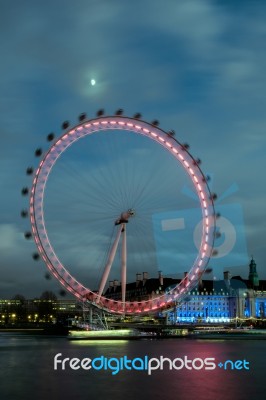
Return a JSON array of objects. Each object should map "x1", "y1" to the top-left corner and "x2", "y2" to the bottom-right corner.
[{"x1": 22, "y1": 110, "x2": 216, "y2": 314}]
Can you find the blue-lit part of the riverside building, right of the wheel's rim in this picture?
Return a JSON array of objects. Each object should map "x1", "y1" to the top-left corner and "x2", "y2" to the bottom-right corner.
[{"x1": 168, "y1": 258, "x2": 266, "y2": 323}]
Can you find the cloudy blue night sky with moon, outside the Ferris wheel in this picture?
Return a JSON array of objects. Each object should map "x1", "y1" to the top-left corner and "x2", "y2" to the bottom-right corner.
[{"x1": 0, "y1": 0, "x2": 266, "y2": 298}]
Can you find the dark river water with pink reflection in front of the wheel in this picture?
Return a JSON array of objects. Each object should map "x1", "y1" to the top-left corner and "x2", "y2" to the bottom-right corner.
[{"x1": 0, "y1": 333, "x2": 266, "y2": 400}]
